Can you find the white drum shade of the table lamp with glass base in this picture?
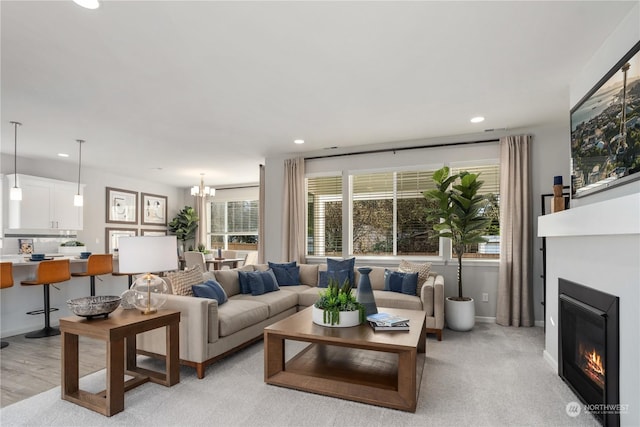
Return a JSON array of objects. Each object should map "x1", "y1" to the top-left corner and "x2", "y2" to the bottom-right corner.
[{"x1": 118, "y1": 236, "x2": 178, "y2": 273}]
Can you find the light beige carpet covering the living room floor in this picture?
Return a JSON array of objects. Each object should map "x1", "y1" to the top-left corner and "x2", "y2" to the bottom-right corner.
[{"x1": 0, "y1": 324, "x2": 599, "y2": 427}]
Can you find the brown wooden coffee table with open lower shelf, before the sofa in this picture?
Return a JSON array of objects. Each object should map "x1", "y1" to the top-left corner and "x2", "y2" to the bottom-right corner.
[{"x1": 264, "y1": 307, "x2": 426, "y2": 412}]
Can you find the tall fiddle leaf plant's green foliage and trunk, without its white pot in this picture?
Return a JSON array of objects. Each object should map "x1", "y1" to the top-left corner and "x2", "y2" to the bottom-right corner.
[{"x1": 423, "y1": 166, "x2": 491, "y2": 301}]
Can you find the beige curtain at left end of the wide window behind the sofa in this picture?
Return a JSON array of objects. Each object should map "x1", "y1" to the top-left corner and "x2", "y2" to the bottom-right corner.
[{"x1": 282, "y1": 157, "x2": 307, "y2": 263}]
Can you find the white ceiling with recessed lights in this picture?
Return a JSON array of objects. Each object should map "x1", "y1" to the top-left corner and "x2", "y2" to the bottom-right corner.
[{"x1": 0, "y1": 0, "x2": 637, "y2": 187}]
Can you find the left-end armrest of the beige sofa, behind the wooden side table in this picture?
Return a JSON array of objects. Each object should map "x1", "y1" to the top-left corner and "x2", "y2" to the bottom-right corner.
[{"x1": 137, "y1": 295, "x2": 218, "y2": 362}]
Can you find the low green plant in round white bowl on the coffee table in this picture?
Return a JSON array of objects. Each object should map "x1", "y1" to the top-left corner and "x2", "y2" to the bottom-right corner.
[{"x1": 313, "y1": 278, "x2": 366, "y2": 328}]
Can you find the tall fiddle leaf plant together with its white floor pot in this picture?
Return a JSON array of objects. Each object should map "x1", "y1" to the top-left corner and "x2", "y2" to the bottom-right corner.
[{"x1": 423, "y1": 166, "x2": 491, "y2": 331}]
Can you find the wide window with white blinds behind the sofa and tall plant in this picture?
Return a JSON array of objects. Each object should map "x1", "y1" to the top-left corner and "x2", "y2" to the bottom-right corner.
[{"x1": 306, "y1": 163, "x2": 500, "y2": 259}]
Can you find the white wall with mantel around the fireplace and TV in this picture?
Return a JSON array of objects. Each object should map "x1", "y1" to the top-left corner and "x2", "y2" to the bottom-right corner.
[{"x1": 540, "y1": 4, "x2": 640, "y2": 426}]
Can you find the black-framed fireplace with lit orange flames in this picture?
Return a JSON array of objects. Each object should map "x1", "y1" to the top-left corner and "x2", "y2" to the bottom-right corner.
[{"x1": 558, "y1": 279, "x2": 620, "y2": 426}]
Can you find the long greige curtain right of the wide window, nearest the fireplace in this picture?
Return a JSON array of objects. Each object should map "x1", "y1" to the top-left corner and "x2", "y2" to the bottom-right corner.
[{"x1": 496, "y1": 135, "x2": 535, "y2": 326}]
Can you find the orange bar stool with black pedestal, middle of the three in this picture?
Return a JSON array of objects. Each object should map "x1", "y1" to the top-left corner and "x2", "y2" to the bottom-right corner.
[{"x1": 20, "y1": 259, "x2": 71, "y2": 338}]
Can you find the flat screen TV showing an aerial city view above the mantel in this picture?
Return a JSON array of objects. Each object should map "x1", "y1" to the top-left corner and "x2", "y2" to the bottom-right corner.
[{"x1": 571, "y1": 42, "x2": 640, "y2": 197}]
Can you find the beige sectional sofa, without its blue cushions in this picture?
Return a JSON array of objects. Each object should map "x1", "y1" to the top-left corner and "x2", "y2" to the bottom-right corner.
[{"x1": 137, "y1": 264, "x2": 444, "y2": 378}]
